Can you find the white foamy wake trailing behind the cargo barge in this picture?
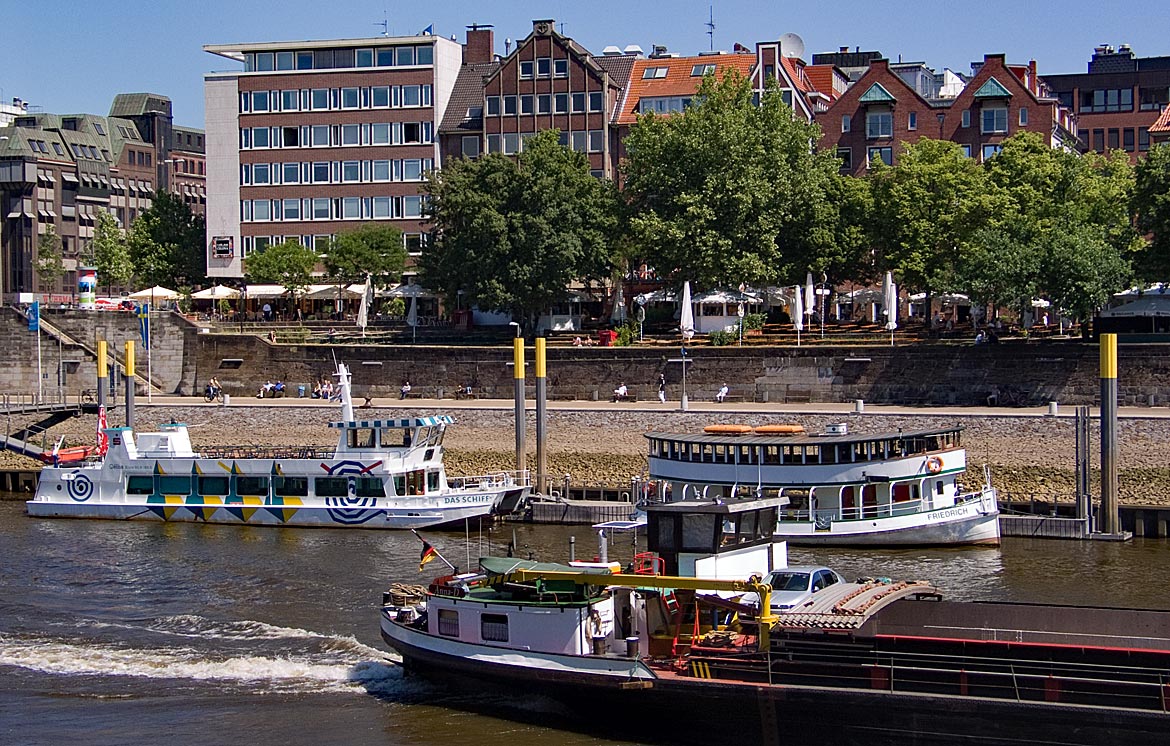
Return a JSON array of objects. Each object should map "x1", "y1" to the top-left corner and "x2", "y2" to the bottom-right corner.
[{"x1": 0, "y1": 615, "x2": 418, "y2": 697}]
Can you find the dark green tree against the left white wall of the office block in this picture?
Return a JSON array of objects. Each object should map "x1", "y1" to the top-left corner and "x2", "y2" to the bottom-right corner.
[{"x1": 131, "y1": 192, "x2": 207, "y2": 285}]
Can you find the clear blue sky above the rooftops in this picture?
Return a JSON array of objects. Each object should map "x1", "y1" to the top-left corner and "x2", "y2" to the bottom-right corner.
[{"x1": 0, "y1": 0, "x2": 1170, "y2": 127}]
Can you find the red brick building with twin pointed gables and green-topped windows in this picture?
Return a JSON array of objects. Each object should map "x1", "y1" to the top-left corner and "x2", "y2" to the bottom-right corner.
[{"x1": 818, "y1": 55, "x2": 1075, "y2": 175}]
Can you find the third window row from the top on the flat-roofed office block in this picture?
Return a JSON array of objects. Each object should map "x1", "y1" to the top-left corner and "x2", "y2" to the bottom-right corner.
[{"x1": 240, "y1": 122, "x2": 434, "y2": 150}]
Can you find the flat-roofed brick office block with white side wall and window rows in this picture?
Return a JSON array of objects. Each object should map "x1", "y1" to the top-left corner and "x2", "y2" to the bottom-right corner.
[{"x1": 204, "y1": 34, "x2": 462, "y2": 277}]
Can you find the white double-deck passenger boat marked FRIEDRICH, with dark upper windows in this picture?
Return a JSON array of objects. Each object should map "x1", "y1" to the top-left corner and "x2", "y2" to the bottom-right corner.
[{"x1": 646, "y1": 424, "x2": 999, "y2": 546}]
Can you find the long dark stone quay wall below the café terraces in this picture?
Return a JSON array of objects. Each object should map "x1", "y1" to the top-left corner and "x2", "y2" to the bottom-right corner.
[{"x1": 0, "y1": 309, "x2": 1170, "y2": 406}]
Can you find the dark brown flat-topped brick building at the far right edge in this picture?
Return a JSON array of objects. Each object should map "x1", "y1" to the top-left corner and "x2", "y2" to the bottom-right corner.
[{"x1": 1044, "y1": 44, "x2": 1170, "y2": 163}]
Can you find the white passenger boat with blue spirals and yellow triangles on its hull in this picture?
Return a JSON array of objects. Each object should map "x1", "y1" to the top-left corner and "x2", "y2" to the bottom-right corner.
[{"x1": 27, "y1": 365, "x2": 529, "y2": 529}]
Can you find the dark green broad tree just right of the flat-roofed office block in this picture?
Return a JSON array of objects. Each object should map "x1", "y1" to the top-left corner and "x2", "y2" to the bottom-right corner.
[{"x1": 420, "y1": 130, "x2": 618, "y2": 329}]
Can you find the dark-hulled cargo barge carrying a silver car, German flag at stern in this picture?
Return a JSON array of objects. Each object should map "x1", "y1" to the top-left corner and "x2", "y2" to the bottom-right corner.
[{"x1": 380, "y1": 498, "x2": 1170, "y2": 746}]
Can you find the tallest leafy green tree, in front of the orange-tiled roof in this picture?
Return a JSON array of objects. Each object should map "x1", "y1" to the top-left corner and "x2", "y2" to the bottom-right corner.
[{"x1": 624, "y1": 71, "x2": 838, "y2": 286}]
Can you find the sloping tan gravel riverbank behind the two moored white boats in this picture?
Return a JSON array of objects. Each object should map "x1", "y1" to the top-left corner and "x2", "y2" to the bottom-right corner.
[{"x1": 9, "y1": 406, "x2": 1170, "y2": 505}]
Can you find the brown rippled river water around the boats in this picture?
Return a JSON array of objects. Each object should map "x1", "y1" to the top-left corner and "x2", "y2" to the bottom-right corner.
[{"x1": 0, "y1": 502, "x2": 1170, "y2": 746}]
